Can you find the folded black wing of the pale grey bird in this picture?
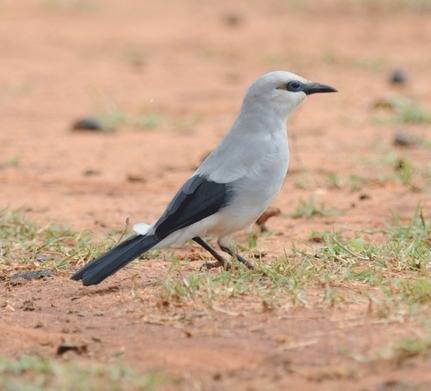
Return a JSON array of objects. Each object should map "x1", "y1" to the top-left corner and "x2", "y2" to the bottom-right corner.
[{"x1": 155, "y1": 175, "x2": 232, "y2": 240}]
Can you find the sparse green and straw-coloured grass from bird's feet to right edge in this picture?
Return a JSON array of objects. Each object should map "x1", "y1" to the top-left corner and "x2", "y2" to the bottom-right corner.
[{"x1": 158, "y1": 208, "x2": 431, "y2": 315}]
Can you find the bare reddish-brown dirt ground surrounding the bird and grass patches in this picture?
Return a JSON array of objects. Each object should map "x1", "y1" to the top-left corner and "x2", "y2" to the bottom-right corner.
[{"x1": 0, "y1": 0, "x2": 431, "y2": 390}]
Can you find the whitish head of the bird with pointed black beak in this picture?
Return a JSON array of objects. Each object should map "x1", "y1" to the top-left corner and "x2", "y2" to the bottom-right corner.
[{"x1": 244, "y1": 71, "x2": 337, "y2": 119}]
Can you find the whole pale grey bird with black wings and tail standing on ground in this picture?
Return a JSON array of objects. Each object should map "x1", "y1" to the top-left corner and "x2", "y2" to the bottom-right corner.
[{"x1": 71, "y1": 71, "x2": 337, "y2": 286}]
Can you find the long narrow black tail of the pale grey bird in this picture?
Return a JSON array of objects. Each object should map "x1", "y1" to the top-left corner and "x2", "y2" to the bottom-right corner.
[{"x1": 72, "y1": 235, "x2": 159, "y2": 285}]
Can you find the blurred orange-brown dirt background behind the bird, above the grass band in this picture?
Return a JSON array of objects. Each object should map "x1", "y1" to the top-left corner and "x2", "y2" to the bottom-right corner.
[{"x1": 0, "y1": 0, "x2": 431, "y2": 234}]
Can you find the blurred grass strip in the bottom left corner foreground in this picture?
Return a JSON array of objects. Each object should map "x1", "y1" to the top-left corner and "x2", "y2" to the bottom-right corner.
[{"x1": 0, "y1": 356, "x2": 172, "y2": 391}]
